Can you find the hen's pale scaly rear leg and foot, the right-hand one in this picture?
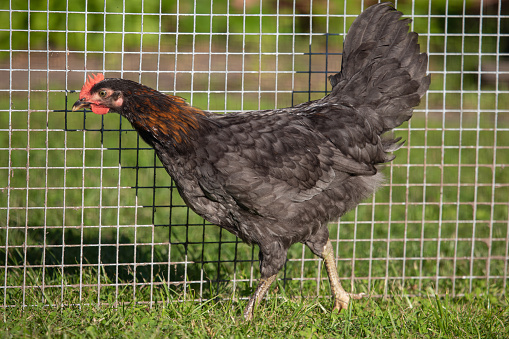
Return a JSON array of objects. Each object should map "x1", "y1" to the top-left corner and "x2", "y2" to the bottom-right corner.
[{"x1": 322, "y1": 239, "x2": 364, "y2": 312}]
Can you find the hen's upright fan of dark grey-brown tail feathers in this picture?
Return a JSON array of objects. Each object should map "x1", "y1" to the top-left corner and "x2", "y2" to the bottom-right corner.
[{"x1": 328, "y1": 3, "x2": 430, "y2": 133}]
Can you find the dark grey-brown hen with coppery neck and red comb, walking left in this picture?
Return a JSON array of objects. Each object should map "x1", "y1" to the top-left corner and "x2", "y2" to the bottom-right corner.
[{"x1": 72, "y1": 4, "x2": 430, "y2": 320}]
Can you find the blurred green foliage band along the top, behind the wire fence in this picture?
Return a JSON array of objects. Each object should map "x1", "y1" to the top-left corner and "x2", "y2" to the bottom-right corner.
[{"x1": 0, "y1": 0, "x2": 502, "y2": 90}]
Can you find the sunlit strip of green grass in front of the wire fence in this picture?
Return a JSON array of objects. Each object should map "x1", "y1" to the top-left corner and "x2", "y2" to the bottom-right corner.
[{"x1": 0, "y1": 291, "x2": 509, "y2": 338}]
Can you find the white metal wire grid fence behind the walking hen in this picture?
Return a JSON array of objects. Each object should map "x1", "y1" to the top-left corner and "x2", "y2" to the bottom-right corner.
[{"x1": 0, "y1": 0, "x2": 509, "y2": 307}]
